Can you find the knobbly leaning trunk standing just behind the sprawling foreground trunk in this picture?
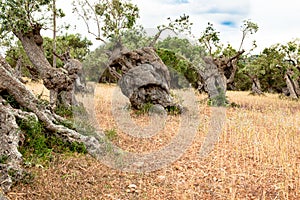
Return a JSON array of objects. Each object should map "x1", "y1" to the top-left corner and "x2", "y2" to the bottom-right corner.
[{"x1": 15, "y1": 25, "x2": 82, "y2": 109}]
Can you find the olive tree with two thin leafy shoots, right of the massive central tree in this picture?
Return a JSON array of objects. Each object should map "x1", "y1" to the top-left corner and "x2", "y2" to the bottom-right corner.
[{"x1": 199, "y1": 20, "x2": 258, "y2": 105}]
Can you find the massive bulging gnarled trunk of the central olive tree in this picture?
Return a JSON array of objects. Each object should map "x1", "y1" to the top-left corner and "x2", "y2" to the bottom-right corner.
[{"x1": 108, "y1": 47, "x2": 180, "y2": 109}]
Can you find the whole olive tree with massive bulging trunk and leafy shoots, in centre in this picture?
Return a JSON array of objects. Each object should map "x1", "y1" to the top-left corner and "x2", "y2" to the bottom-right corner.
[{"x1": 74, "y1": 0, "x2": 190, "y2": 109}]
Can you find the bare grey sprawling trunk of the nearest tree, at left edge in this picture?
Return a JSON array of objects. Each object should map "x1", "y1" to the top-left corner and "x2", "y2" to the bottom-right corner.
[{"x1": 0, "y1": 56, "x2": 103, "y2": 195}]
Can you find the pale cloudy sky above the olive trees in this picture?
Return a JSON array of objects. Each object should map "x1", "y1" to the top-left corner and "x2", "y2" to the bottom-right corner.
[{"x1": 52, "y1": 0, "x2": 300, "y2": 53}]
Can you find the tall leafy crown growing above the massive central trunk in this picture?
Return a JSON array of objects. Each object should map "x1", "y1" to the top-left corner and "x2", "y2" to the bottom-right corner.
[{"x1": 73, "y1": 0, "x2": 139, "y2": 41}]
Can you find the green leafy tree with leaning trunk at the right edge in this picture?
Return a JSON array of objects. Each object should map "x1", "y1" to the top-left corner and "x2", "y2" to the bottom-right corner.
[{"x1": 241, "y1": 40, "x2": 300, "y2": 99}]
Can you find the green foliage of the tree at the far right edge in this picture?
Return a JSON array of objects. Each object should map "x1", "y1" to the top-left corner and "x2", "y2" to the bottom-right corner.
[{"x1": 236, "y1": 41, "x2": 300, "y2": 93}]
